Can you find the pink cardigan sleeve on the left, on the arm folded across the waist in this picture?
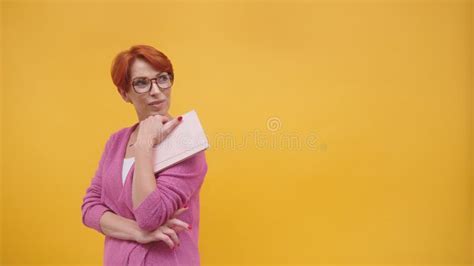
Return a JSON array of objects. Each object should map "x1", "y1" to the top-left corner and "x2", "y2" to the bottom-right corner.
[{"x1": 81, "y1": 137, "x2": 113, "y2": 235}]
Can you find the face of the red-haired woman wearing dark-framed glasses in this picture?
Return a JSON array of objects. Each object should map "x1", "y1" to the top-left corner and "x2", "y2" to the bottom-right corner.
[{"x1": 120, "y1": 58, "x2": 171, "y2": 121}]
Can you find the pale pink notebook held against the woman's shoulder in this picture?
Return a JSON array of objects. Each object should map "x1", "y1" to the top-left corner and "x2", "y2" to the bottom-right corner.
[{"x1": 153, "y1": 110, "x2": 209, "y2": 173}]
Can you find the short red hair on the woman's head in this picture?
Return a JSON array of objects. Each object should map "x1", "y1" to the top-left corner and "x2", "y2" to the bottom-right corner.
[{"x1": 111, "y1": 45, "x2": 174, "y2": 92}]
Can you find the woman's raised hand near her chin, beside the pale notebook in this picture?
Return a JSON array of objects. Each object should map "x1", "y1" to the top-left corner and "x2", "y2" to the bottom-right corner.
[{"x1": 134, "y1": 115, "x2": 182, "y2": 147}]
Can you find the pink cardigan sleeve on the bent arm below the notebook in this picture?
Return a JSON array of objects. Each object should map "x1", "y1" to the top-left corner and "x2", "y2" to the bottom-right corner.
[{"x1": 133, "y1": 151, "x2": 207, "y2": 231}]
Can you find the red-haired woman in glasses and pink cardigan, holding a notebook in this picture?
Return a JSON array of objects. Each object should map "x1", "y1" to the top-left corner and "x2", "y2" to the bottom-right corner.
[{"x1": 81, "y1": 45, "x2": 207, "y2": 266}]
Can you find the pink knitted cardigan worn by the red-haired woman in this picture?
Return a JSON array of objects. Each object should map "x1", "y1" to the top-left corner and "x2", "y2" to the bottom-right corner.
[{"x1": 81, "y1": 123, "x2": 207, "y2": 266}]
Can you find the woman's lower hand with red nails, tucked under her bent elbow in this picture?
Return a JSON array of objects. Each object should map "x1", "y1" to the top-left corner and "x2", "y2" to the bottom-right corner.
[{"x1": 136, "y1": 207, "x2": 189, "y2": 249}]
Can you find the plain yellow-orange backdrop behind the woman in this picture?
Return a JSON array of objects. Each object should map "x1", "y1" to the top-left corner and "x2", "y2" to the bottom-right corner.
[{"x1": 0, "y1": 0, "x2": 474, "y2": 265}]
